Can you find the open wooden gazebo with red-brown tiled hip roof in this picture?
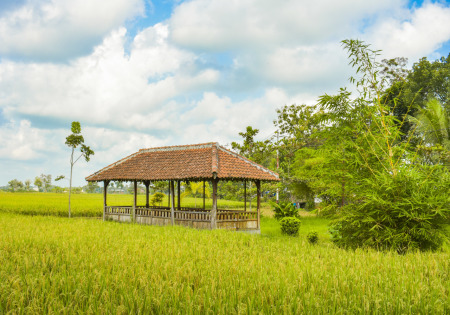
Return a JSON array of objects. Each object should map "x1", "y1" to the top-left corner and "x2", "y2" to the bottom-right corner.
[{"x1": 86, "y1": 142, "x2": 279, "y2": 231}]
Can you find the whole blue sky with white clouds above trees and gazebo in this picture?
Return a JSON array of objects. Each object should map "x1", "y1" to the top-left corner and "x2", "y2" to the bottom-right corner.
[{"x1": 0, "y1": 0, "x2": 450, "y2": 186}]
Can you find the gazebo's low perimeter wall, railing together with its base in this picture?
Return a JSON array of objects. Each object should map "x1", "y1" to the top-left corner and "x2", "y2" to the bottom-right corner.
[{"x1": 105, "y1": 206, "x2": 258, "y2": 231}]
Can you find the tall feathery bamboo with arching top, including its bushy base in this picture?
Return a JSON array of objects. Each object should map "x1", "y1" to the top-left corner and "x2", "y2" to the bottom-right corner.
[{"x1": 317, "y1": 40, "x2": 450, "y2": 253}]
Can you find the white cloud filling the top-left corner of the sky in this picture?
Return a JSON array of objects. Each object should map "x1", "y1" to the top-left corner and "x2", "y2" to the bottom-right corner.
[{"x1": 0, "y1": 0, "x2": 144, "y2": 60}]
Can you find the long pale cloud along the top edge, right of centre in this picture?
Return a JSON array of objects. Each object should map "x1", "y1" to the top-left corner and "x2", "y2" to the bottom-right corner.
[{"x1": 170, "y1": 0, "x2": 403, "y2": 51}]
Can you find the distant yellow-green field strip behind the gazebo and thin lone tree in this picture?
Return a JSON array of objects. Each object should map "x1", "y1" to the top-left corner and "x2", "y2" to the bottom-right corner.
[{"x1": 0, "y1": 192, "x2": 269, "y2": 217}]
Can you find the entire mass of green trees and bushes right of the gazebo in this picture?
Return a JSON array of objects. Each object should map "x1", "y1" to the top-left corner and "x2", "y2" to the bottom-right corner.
[{"x1": 230, "y1": 40, "x2": 450, "y2": 253}]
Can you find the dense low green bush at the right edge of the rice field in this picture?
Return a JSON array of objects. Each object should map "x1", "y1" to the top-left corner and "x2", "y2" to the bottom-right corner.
[{"x1": 330, "y1": 166, "x2": 450, "y2": 253}]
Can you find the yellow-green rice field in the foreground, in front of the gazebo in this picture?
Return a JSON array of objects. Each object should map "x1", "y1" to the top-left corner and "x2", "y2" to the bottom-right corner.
[{"x1": 0, "y1": 213, "x2": 450, "y2": 314}]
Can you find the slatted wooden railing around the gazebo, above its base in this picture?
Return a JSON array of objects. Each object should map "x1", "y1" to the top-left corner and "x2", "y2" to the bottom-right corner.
[{"x1": 105, "y1": 206, "x2": 258, "y2": 222}]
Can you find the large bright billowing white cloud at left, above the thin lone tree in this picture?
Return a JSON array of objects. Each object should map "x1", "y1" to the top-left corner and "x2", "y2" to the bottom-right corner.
[{"x1": 0, "y1": 24, "x2": 219, "y2": 129}]
